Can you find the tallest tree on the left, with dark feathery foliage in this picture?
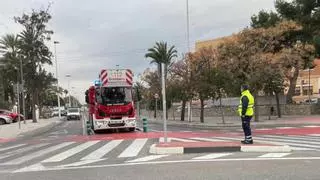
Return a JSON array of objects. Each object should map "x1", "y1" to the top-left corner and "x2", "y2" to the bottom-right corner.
[{"x1": 15, "y1": 9, "x2": 53, "y2": 122}]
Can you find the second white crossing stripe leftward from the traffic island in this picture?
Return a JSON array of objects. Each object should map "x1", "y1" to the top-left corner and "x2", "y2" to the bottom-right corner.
[{"x1": 81, "y1": 140, "x2": 123, "y2": 160}]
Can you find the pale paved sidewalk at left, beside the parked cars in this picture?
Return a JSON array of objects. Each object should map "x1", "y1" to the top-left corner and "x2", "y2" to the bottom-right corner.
[{"x1": 0, "y1": 118, "x2": 62, "y2": 142}]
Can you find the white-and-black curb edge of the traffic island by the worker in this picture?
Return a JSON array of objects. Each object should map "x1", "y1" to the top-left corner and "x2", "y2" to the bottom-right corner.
[{"x1": 149, "y1": 144, "x2": 292, "y2": 154}]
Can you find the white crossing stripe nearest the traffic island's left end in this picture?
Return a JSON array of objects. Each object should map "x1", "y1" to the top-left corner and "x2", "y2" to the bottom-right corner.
[{"x1": 118, "y1": 138, "x2": 148, "y2": 158}]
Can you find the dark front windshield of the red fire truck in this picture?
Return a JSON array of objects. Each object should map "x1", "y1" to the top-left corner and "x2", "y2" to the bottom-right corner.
[{"x1": 101, "y1": 87, "x2": 132, "y2": 105}]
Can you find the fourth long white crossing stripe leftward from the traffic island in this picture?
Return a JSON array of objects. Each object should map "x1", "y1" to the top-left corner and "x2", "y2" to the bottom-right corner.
[{"x1": 4, "y1": 142, "x2": 74, "y2": 165}]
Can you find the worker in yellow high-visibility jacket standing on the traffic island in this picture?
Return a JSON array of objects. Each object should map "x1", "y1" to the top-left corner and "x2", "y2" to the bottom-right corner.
[{"x1": 238, "y1": 85, "x2": 254, "y2": 144}]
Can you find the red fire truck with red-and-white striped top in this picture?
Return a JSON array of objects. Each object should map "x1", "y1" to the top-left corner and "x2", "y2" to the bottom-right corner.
[{"x1": 86, "y1": 69, "x2": 136, "y2": 132}]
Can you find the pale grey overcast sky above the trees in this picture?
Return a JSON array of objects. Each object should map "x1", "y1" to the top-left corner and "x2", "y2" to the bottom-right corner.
[{"x1": 0, "y1": 0, "x2": 274, "y2": 102}]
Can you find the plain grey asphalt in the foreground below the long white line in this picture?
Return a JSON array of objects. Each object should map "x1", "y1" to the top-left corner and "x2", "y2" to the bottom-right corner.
[{"x1": 0, "y1": 159, "x2": 320, "y2": 180}]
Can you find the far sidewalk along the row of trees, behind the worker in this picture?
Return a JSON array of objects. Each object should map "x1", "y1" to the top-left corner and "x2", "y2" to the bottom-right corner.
[{"x1": 144, "y1": 116, "x2": 320, "y2": 129}]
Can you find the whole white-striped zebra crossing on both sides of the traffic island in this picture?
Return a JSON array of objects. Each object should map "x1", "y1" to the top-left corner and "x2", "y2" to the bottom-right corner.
[{"x1": 0, "y1": 135, "x2": 320, "y2": 171}]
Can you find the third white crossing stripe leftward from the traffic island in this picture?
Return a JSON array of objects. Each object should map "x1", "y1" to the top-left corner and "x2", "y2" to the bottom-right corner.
[{"x1": 42, "y1": 141, "x2": 100, "y2": 163}]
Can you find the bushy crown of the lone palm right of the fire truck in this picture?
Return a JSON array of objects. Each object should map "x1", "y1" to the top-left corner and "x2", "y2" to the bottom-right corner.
[{"x1": 145, "y1": 42, "x2": 177, "y2": 78}]
